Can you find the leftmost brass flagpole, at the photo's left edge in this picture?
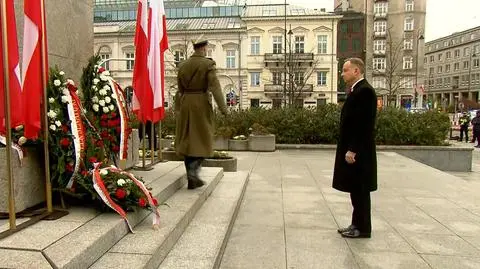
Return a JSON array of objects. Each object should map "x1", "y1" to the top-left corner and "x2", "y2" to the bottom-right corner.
[{"x1": 1, "y1": 0, "x2": 17, "y2": 230}]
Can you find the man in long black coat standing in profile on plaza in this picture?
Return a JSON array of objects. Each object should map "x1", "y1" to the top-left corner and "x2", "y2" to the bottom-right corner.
[{"x1": 332, "y1": 58, "x2": 377, "y2": 238}]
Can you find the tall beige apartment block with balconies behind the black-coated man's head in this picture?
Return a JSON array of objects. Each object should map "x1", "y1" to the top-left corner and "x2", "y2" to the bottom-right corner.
[{"x1": 334, "y1": 0, "x2": 426, "y2": 106}]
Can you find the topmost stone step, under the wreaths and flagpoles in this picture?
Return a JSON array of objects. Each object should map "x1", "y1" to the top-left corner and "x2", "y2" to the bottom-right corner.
[{"x1": 5, "y1": 162, "x2": 186, "y2": 268}]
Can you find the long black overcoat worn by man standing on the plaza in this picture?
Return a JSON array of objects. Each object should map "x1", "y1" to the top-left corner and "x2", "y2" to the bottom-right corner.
[{"x1": 332, "y1": 79, "x2": 377, "y2": 192}]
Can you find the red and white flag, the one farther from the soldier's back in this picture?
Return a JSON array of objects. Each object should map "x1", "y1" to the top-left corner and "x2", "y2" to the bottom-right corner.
[{"x1": 132, "y1": 0, "x2": 148, "y2": 122}]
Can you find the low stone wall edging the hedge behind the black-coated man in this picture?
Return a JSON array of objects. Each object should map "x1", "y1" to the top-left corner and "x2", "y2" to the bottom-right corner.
[{"x1": 276, "y1": 144, "x2": 473, "y2": 172}]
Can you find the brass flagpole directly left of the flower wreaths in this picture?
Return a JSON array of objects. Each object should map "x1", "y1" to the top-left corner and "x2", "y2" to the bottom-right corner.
[{"x1": 40, "y1": 0, "x2": 53, "y2": 213}]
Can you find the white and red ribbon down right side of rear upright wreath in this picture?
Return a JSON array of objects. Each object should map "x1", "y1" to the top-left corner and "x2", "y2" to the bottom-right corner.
[{"x1": 108, "y1": 77, "x2": 128, "y2": 160}]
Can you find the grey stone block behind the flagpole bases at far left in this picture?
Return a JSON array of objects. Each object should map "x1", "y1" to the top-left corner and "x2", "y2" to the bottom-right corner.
[{"x1": 0, "y1": 148, "x2": 45, "y2": 213}]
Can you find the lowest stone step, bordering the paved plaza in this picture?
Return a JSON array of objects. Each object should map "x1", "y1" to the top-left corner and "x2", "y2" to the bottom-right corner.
[{"x1": 158, "y1": 171, "x2": 249, "y2": 269}]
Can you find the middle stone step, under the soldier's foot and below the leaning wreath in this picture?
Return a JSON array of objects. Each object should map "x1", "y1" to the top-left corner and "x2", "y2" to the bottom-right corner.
[{"x1": 90, "y1": 167, "x2": 223, "y2": 269}]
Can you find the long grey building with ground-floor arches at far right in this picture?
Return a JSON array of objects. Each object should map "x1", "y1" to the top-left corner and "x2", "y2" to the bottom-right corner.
[{"x1": 424, "y1": 26, "x2": 480, "y2": 108}]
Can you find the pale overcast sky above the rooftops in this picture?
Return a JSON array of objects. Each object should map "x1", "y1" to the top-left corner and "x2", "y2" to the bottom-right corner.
[{"x1": 260, "y1": 0, "x2": 480, "y2": 41}]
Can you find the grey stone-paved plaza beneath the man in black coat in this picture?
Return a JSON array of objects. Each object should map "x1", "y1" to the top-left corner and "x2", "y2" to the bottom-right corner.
[{"x1": 221, "y1": 150, "x2": 480, "y2": 269}]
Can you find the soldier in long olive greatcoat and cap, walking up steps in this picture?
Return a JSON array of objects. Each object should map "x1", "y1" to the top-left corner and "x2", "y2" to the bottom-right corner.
[{"x1": 175, "y1": 40, "x2": 227, "y2": 189}]
